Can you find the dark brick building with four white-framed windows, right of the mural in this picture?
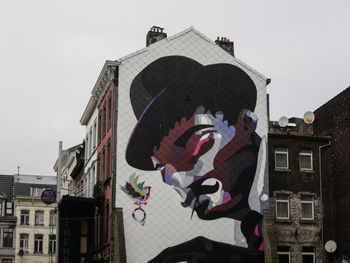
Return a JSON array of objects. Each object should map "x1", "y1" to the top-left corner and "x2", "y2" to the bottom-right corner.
[{"x1": 267, "y1": 118, "x2": 330, "y2": 263}]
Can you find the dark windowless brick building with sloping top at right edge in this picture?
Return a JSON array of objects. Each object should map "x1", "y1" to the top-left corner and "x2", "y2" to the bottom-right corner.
[{"x1": 314, "y1": 87, "x2": 350, "y2": 262}]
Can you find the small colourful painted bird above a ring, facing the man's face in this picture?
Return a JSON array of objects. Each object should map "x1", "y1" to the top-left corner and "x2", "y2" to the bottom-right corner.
[{"x1": 120, "y1": 174, "x2": 151, "y2": 226}]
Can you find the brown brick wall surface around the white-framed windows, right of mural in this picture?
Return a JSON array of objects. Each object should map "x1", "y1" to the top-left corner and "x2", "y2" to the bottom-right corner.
[{"x1": 269, "y1": 130, "x2": 330, "y2": 262}]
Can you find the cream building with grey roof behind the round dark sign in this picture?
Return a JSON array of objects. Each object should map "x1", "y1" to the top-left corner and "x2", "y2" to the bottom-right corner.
[{"x1": 14, "y1": 174, "x2": 56, "y2": 263}]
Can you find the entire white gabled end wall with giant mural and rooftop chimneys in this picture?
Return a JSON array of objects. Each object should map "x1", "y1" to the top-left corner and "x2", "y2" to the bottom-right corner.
[{"x1": 112, "y1": 27, "x2": 269, "y2": 262}]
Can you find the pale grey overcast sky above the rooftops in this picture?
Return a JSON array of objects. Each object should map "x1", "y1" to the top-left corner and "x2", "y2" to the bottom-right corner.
[{"x1": 0, "y1": 0, "x2": 350, "y2": 175}]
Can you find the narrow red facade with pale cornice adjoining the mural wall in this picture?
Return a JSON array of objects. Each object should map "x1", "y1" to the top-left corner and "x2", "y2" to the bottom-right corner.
[{"x1": 92, "y1": 61, "x2": 118, "y2": 262}]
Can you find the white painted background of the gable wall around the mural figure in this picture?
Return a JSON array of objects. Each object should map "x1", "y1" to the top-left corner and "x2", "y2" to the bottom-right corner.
[{"x1": 115, "y1": 28, "x2": 268, "y2": 262}]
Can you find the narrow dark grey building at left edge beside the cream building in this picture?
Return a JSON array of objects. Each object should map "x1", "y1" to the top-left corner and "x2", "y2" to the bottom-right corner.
[{"x1": 0, "y1": 174, "x2": 16, "y2": 263}]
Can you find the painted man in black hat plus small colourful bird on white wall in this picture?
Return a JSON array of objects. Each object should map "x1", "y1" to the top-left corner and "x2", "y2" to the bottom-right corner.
[{"x1": 123, "y1": 56, "x2": 266, "y2": 262}]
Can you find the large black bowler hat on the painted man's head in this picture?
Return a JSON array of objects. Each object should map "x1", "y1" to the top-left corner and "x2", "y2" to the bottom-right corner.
[{"x1": 126, "y1": 56, "x2": 257, "y2": 170}]
